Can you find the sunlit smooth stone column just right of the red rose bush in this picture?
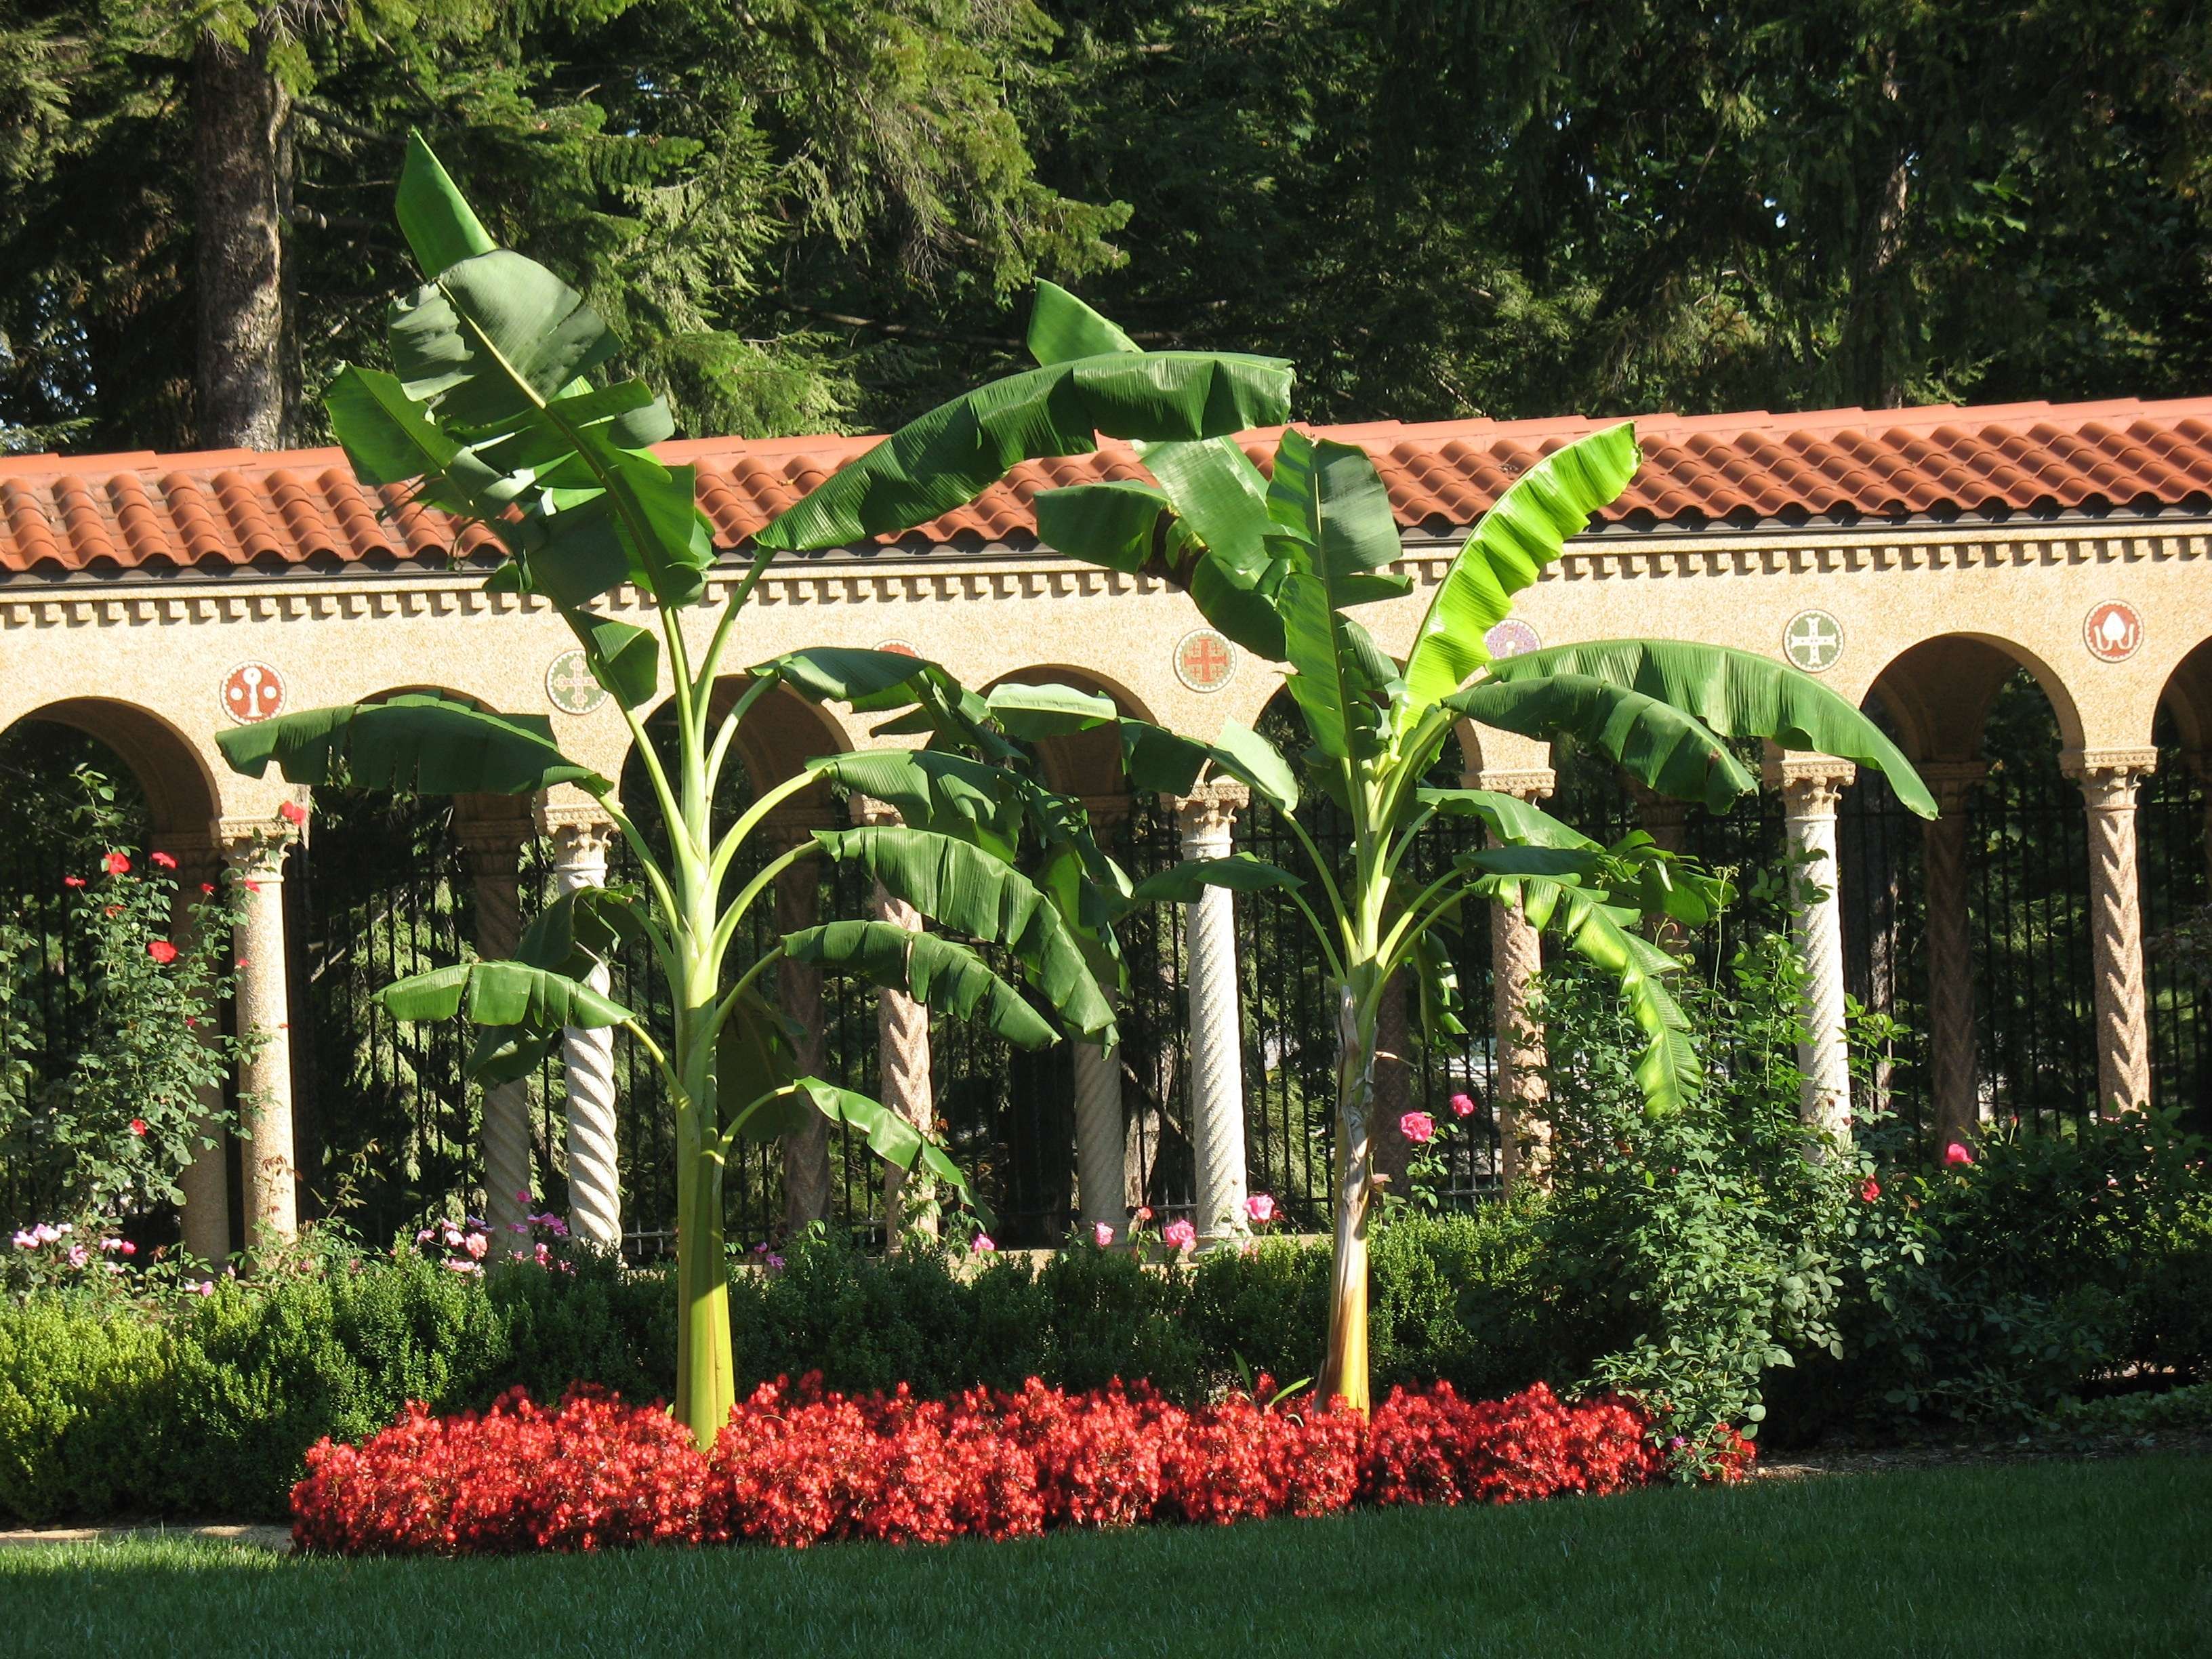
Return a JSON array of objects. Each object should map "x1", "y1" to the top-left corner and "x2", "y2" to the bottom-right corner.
[{"x1": 219, "y1": 819, "x2": 299, "y2": 1250}]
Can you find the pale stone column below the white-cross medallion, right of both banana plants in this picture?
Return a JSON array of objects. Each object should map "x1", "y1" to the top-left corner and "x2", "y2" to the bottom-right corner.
[{"x1": 1767, "y1": 754, "x2": 1858, "y2": 1134}]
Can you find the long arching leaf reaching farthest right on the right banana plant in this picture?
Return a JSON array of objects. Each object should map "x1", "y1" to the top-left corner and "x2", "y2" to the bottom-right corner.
[{"x1": 1491, "y1": 639, "x2": 1936, "y2": 819}]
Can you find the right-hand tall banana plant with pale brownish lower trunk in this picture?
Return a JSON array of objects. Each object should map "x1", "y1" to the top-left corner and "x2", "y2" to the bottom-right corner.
[{"x1": 1031, "y1": 294, "x2": 1936, "y2": 1409}]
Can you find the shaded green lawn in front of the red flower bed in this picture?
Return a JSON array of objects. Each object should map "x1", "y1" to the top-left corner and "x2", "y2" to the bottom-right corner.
[{"x1": 0, "y1": 1456, "x2": 2212, "y2": 1659}]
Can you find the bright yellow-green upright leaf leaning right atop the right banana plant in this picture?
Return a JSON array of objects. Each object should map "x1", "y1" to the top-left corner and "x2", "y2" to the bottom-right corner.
[{"x1": 1400, "y1": 425, "x2": 1641, "y2": 730}]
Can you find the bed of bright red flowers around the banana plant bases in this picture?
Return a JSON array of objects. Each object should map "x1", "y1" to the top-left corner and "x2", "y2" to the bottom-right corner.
[{"x1": 292, "y1": 1378, "x2": 1752, "y2": 1555}]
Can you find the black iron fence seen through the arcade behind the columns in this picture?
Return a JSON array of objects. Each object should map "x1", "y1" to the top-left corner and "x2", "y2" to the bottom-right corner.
[{"x1": 0, "y1": 677, "x2": 2212, "y2": 1252}]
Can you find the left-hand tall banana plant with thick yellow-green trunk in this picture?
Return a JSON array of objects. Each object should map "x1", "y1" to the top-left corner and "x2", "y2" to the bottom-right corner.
[{"x1": 219, "y1": 140, "x2": 1290, "y2": 1444}]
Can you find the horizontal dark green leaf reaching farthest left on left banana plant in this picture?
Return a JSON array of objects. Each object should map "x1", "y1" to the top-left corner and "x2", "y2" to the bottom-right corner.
[{"x1": 215, "y1": 693, "x2": 615, "y2": 794}]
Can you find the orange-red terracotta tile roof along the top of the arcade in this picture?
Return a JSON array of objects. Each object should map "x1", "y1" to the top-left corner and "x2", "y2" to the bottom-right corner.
[{"x1": 0, "y1": 398, "x2": 2212, "y2": 575}]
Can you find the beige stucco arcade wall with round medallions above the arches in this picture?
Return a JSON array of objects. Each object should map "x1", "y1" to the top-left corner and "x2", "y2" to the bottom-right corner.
[{"x1": 0, "y1": 506, "x2": 2212, "y2": 832}]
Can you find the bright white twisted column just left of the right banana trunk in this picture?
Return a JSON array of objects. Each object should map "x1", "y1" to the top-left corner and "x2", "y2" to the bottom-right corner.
[{"x1": 1168, "y1": 779, "x2": 1252, "y2": 1239}]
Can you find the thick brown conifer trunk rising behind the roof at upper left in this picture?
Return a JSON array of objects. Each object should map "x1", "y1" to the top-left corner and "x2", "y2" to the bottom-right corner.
[{"x1": 192, "y1": 33, "x2": 290, "y2": 449}]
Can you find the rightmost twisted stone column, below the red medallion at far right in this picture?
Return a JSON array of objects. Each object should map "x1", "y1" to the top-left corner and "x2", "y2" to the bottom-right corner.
[{"x1": 2060, "y1": 747, "x2": 2159, "y2": 1113}]
